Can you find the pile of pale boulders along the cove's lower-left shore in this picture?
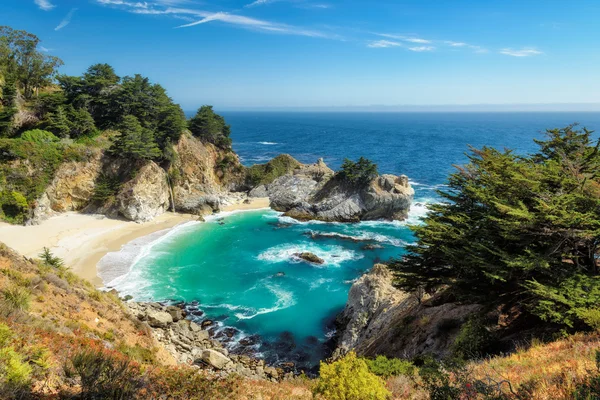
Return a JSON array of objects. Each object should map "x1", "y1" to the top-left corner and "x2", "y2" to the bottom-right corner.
[{"x1": 125, "y1": 302, "x2": 293, "y2": 381}]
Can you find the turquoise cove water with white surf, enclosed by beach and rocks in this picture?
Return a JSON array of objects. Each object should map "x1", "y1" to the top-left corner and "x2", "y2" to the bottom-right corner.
[{"x1": 99, "y1": 207, "x2": 419, "y2": 368}]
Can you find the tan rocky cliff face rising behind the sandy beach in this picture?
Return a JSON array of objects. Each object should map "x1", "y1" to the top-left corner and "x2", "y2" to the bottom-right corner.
[{"x1": 29, "y1": 134, "x2": 243, "y2": 223}]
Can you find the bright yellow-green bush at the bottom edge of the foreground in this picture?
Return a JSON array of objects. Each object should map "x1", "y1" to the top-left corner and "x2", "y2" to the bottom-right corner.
[{"x1": 314, "y1": 352, "x2": 390, "y2": 400}]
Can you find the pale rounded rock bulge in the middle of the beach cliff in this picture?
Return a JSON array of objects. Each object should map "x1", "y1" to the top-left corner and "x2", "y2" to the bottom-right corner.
[{"x1": 116, "y1": 162, "x2": 170, "y2": 222}]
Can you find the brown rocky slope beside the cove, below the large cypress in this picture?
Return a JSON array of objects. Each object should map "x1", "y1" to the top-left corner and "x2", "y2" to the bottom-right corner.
[{"x1": 334, "y1": 264, "x2": 481, "y2": 358}]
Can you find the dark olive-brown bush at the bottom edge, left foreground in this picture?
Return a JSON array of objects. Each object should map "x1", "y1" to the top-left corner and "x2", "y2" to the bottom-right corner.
[{"x1": 63, "y1": 349, "x2": 143, "y2": 400}]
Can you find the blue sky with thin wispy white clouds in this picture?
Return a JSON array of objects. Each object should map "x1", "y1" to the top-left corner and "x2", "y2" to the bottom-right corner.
[{"x1": 0, "y1": 0, "x2": 600, "y2": 110}]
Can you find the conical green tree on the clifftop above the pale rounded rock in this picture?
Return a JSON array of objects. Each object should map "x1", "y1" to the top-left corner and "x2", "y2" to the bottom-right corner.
[{"x1": 109, "y1": 115, "x2": 161, "y2": 160}]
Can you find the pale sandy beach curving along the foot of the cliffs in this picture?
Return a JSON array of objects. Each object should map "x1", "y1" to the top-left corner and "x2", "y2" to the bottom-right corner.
[{"x1": 0, "y1": 198, "x2": 269, "y2": 286}]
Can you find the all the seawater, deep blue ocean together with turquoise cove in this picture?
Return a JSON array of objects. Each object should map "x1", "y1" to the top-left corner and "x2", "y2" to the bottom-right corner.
[{"x1": 99, "y1": 112, "x2": 600, "y2": 369}]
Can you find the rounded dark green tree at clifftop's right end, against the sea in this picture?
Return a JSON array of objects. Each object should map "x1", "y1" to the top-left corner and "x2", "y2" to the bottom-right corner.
[{"x1": 188, "y1": 106, "x2": 231, "y2": 149}]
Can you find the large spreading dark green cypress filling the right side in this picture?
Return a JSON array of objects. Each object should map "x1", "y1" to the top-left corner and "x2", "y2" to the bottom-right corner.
[{"x1": 392, "y1": 126, "x2": 600, "y2": 328}]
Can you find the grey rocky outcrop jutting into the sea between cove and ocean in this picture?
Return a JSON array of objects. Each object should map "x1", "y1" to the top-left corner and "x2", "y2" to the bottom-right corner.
[{"x1": 255, "y1": 156, "x2": 414, "y2": 222}]
